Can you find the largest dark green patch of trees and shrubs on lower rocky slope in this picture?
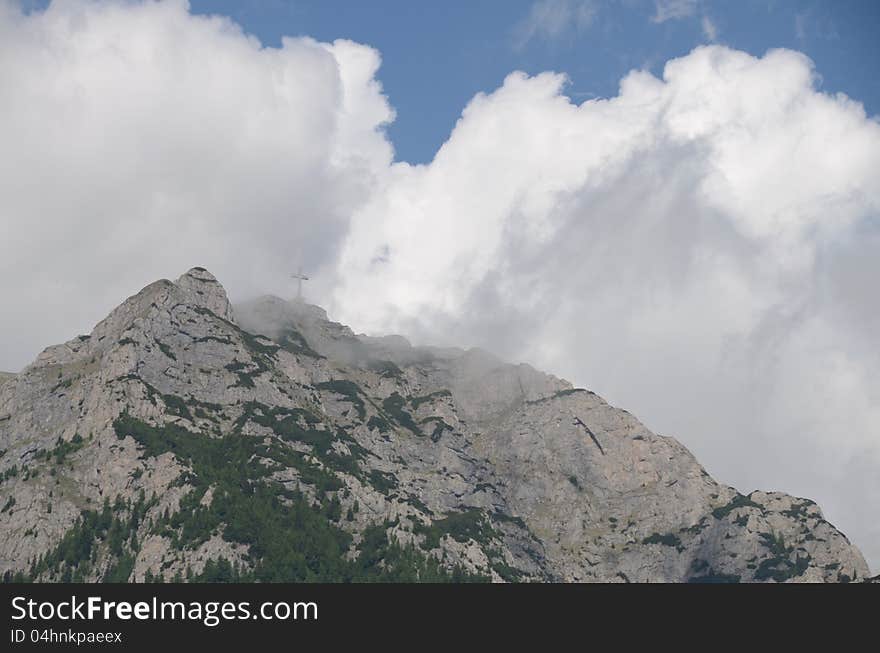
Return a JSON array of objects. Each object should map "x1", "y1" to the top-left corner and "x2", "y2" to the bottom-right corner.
[{"x1": 114, "y1": 406, "x2": 479, "y2": 582}]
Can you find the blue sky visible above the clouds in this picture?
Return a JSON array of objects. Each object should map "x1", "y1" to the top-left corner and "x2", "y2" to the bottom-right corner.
[{"x1": 184, "y1": 0, "x2": 880, "y2": 163}]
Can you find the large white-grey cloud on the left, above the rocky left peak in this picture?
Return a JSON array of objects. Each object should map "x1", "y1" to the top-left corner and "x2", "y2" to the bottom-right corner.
[{"x1": 0, "y1": 1, "x2": 394, "y2": 369}]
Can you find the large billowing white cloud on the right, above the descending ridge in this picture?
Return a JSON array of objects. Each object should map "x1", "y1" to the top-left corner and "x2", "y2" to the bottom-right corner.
[{"x1": 331, "y1": 46, "x2": 880, "y2": 566}]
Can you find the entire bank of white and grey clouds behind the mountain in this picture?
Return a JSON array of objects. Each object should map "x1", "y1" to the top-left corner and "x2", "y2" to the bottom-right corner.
[{"x1": 0, "y1": 0, "x2": 880, "y2": 568}]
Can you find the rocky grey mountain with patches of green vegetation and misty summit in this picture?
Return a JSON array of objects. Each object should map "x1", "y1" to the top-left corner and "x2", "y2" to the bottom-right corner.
[{"x1": 0, "y1": 268, "x2": 868, "y2": 582}]
